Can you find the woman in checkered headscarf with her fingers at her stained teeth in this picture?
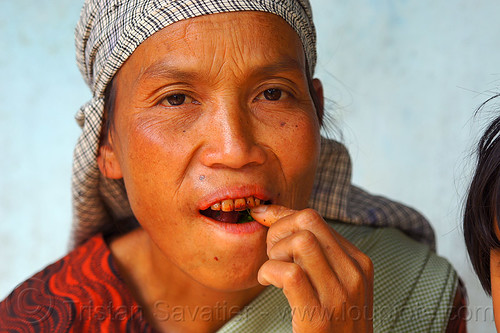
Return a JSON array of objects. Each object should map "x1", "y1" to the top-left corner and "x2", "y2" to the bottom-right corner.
[{"x1": 0, "y1": 0, "x2": 457, "y2": 332}]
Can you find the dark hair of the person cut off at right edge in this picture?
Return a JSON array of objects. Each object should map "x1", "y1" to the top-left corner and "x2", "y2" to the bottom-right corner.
[{"x1": 464, "y1": 95, "x2": 500, "y2": 294}]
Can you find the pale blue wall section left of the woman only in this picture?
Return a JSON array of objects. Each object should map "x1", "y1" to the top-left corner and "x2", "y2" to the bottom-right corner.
[{"x1": 0, "y1": 0, "x2": 90, "y2": 306}]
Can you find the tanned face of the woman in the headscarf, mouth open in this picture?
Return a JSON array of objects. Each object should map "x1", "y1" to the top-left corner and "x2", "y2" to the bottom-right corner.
[{"x1": 105, "y1": 12, "x2": 321, "y2": 290}]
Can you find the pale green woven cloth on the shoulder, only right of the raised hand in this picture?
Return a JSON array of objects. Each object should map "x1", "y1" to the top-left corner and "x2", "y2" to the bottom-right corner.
[{"x1": 331, "y1": 223, "x2": 459, "y2": 332}]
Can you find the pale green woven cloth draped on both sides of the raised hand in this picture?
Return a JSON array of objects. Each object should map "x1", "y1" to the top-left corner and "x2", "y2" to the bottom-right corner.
[{"x1": 217, "y1": 221, "x2": 458, "y2": 333}]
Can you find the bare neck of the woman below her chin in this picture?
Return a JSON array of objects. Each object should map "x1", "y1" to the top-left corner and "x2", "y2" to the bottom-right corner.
[{"x1": 110, "y1": 228, "x2": 264, "y2": 332}]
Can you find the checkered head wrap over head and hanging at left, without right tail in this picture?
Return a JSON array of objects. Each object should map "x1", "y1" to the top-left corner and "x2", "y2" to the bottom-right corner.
[{"x1": 72, "y1": 0, "x2": 316, "y2": 245}]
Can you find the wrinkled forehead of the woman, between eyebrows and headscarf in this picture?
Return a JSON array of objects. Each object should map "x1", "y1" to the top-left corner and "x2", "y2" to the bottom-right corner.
[{"x1": 124, "y1": 12, "x2": 307, "y2": 81}]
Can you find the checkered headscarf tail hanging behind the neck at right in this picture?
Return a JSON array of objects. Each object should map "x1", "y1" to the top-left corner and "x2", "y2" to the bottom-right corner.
[{"x1": 309, "y1": 138, "x2": 435, "y2": 249}]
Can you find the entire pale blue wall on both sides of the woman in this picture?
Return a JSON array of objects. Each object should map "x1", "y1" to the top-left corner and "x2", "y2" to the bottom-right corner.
[{"x1": 0, "y1": 0, "x2": 500, "y2": 332}]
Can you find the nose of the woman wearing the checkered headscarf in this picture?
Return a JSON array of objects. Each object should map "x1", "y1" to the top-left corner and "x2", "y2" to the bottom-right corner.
[{"x1": 202, "y1": 104, "x2": 266, "y2": 169}]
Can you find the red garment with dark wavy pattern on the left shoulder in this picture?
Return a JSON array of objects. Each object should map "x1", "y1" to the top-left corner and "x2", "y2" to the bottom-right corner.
[{"x1": 0, "y1": 235, "x2": 153, "y2": 332}]
